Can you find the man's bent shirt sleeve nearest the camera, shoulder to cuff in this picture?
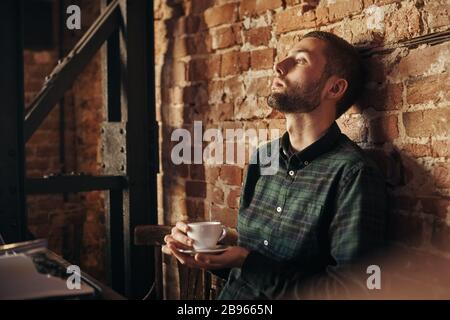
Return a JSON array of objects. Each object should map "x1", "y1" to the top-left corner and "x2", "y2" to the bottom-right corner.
[{"x1": 241, "y1": 165, "x2": 387, "y2": 299}]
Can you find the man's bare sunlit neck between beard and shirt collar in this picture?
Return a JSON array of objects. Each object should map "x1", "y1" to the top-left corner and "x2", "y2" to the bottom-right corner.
[{"x1": 285, "y1": 111, "x2": 334, "y2": 152}]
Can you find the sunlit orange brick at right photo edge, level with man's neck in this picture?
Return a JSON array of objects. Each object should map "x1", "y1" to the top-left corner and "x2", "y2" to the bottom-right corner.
[{"x1": 403, "y1": 108, "x2": 450, "y2": 137}]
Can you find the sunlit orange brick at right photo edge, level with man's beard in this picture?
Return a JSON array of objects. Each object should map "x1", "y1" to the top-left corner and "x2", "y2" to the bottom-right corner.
[{"x1": 406, "y1": 73, "x2": 450, "y2": 104}]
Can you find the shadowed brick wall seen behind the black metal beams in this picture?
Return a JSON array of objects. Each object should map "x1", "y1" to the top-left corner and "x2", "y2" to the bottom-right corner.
[{"x1": 24, "y1": 0, "x2": 105, "y2": 280}]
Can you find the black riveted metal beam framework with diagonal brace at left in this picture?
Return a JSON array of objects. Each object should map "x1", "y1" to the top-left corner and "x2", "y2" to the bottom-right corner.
[{"x1": 0, "y1": 0, "x2": 159, "y2": 298}]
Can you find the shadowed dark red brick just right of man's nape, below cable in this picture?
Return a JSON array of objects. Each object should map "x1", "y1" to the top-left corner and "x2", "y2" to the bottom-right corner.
[{"x1": 361, "y1": 83, "x2": 403, "y2": 111}]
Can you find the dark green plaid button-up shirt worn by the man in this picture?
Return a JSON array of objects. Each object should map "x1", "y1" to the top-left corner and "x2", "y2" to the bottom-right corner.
[{"x1": 219, "y1": 123, "x2": 387, "y2": 299}]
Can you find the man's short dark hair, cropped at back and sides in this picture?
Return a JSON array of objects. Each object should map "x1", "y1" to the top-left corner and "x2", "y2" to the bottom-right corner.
[{"x1": 303, "y1": 31, "x2": 365, "y2": 119}]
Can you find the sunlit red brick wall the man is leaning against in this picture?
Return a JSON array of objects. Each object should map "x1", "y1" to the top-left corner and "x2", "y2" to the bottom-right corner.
[{"x1": 155, "y1": 0, "x2": 450, "y2": 297}]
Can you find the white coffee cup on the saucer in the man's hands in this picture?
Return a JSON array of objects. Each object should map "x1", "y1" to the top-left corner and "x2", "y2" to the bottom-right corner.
[{"x1": 187, "y1": 221, "x2": 226, "y2": 250}]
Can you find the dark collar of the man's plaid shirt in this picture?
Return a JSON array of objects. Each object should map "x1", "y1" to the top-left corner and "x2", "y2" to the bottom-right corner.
[{"x1": 280, "y1": 122, "x2": 341, "y2": 162}]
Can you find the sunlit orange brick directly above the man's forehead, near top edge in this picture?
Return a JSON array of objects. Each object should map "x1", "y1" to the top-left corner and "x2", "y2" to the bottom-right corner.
[{"x1": 275, "y1": 6, "x2": 316, "y2": 34}]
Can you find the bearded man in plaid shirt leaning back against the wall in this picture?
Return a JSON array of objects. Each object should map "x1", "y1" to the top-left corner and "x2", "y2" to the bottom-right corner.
[{"x1": 163, "y1": 31, "x2": 386, "y2": 299}]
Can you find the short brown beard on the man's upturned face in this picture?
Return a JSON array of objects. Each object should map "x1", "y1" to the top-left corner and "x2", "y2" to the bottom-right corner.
[{"x1": 267, "y1": 73, "x2": 328, "y2": 113}]
